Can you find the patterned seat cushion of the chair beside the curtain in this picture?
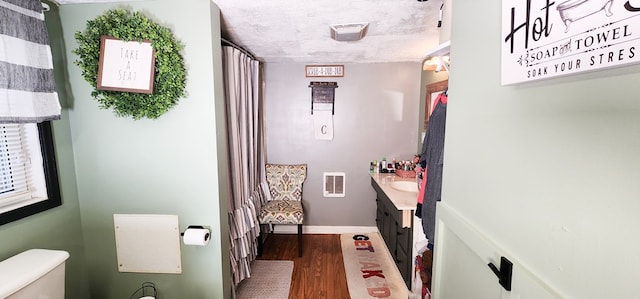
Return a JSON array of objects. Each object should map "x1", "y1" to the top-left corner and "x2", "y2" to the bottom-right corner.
[{"x1": 258, "y1": 200, "x2": 304, "y2": 224}]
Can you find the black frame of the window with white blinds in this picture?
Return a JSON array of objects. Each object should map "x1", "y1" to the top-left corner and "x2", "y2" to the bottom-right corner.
[{"x1": 0, "y1": 121, "x2": 62, "y2": 225}]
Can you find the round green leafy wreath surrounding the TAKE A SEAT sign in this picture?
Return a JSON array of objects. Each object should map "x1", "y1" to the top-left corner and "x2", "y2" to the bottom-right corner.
[{"x1": 72, "y1": 9, "x2": 186, "y2": 120}]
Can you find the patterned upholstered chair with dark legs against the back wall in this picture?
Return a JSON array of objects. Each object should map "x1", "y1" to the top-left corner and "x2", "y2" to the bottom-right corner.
[{"x1": 258, "y1": 164, "x2": 307, "y2": 257}]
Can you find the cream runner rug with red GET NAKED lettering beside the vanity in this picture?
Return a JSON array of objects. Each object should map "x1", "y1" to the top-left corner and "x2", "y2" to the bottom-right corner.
[{"x1": 340, "y1": 233, "x2": 409, "y2": 299}]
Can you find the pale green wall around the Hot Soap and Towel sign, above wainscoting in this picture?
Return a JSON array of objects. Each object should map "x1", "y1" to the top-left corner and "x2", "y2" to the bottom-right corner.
[{"x1": 436, "y1": 1, "x2": 640, "y2": 298}]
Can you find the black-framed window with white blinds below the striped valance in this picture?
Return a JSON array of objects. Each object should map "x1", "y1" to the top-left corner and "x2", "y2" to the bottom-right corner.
[{"x1": 0, "y1": 122, "x2": 62, "y2": 225}]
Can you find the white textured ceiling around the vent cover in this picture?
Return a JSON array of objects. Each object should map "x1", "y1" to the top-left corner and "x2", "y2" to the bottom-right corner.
[{"x1": 54, "y1": 0, "x2": 443, "y2": 63}]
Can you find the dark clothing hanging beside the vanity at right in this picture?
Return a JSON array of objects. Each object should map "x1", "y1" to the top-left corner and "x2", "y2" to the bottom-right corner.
[{"x1": 420, "y1": 91, "x2": 448, "y2": 245}]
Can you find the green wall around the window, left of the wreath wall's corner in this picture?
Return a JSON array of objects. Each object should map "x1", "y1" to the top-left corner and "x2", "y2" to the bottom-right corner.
[{"x1": 0, "y1": 2, "x2": 89, "y2": 298}]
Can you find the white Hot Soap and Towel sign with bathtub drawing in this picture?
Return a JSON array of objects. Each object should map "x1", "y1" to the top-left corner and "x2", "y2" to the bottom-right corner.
[{"x1": 501, "y1": 0, "x2": 640, "y2": 85}]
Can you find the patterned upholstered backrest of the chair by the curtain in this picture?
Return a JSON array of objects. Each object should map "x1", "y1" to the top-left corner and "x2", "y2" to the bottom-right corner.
[{"x1": 265, "y1": 164, "x2": 307, "y2": 201}]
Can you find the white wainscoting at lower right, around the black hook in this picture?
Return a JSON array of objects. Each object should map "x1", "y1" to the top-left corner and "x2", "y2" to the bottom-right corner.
[{"x1": 431, "y1": 202, "x2": 566, "y2": 299}]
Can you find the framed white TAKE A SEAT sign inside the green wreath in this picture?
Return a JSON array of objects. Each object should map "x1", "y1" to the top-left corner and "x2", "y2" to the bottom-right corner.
[{"x1": 97, "y1": 35, "x2": 155, "y2": 94}]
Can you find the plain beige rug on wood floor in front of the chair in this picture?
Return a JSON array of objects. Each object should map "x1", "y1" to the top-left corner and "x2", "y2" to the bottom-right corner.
[{"x1": 236, "y1": 260, "x2": 293, "y2": 299}]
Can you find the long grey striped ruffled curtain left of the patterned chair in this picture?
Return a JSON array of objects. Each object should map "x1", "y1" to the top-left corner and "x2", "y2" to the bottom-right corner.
[{"x1": 222, "y1": 46, "x2": 265, "y2": 286}]
